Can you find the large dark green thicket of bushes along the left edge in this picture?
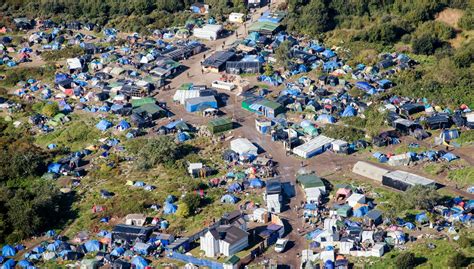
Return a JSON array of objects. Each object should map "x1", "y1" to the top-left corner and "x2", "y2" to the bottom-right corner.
[{"x1": 0, "y1": 121, "x2": 68, "y2": 243}]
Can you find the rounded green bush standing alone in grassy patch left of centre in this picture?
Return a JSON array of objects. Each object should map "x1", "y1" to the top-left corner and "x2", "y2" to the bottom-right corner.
[{"x1": 137, "y1": 136, "x2": 178, "y2": 170}]
